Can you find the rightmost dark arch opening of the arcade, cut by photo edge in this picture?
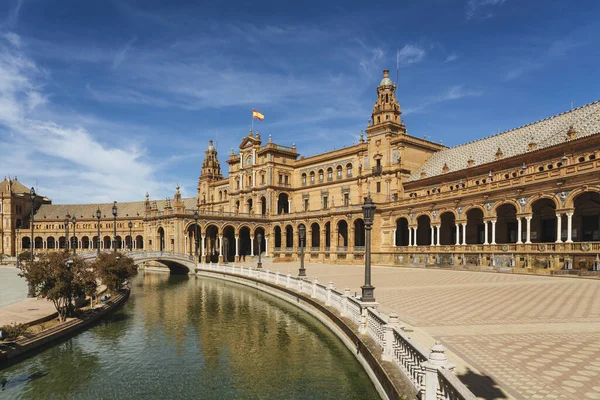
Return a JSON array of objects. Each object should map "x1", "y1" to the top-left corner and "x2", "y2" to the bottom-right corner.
[{"x1": 562, "y1": 191, "x2": 600, "y2": 242}]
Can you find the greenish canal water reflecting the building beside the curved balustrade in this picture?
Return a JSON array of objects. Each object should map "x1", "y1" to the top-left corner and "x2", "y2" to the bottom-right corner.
[{"x1": 0, "y1": 273, "x2": 378, "y2": 400}]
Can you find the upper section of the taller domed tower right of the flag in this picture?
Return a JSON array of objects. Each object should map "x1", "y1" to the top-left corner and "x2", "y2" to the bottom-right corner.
[{"x1": 367, "y1": 69, "x2": 406, "y2": 136}]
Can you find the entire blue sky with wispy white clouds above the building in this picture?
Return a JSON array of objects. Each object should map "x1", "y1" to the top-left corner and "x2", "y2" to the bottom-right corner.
[{"x1": 0, "y1": 0, "x2": 600, "y2": 203}]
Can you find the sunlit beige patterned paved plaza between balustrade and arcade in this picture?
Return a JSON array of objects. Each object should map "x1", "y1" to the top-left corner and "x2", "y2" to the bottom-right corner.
[{"x1": 265, "y1": 263, "x2": 600, "y2": 399}]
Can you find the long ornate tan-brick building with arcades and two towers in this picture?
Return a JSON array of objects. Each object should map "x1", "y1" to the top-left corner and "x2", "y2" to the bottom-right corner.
[{"x1": 0, "y1": 70, "x2": 600, "y2": 269}]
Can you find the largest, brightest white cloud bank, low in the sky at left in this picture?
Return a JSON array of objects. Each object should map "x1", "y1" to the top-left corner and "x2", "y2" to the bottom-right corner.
[{"x1": 0, "y1": 37, "x2": 171, "y2": 203}]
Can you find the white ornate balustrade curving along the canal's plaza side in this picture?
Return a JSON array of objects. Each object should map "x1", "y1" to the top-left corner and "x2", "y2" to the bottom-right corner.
[{"x1": 188, "y1": 260, "x2": 475, "y2": 400}]
